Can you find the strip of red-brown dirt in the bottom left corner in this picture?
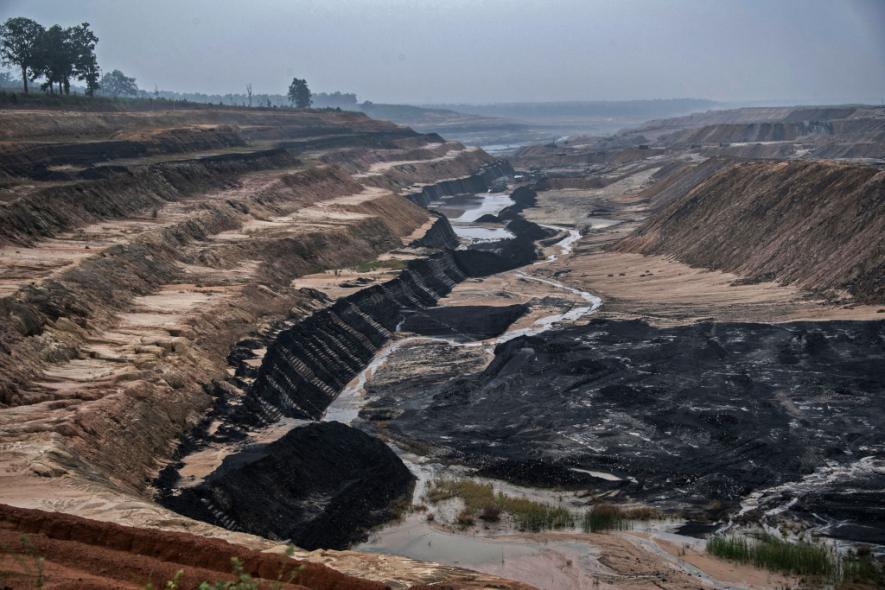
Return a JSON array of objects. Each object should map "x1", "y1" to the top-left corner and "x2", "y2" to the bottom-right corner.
[{"x1": 0, "y1": 505, "x2": 386, "y2": 590}]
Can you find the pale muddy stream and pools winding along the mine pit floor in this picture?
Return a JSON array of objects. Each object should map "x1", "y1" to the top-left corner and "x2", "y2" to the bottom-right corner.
[{"x1": 323, "y1": 193, "x2": 704, "y2": 589}]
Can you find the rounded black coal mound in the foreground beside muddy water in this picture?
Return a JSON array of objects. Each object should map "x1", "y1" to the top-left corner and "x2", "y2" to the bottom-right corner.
[{"x1": 162, "y1": 422, "x2": 414, "y2": 550}]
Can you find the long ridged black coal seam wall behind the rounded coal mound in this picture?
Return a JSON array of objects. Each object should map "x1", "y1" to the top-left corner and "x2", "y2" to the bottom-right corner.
[{"x1": 154, "y1": 177, "x2": 540, "y2": 497}]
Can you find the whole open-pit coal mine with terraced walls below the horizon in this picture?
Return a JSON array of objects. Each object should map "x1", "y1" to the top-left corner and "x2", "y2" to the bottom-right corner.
[{"x1": 0, "y1": 76, "x2": 885, "y2": 590}]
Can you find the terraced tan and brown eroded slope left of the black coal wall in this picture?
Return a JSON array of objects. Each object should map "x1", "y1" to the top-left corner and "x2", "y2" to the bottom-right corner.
[{"x1": 0, "y1": 108, "x2": 487, "y2": 502}]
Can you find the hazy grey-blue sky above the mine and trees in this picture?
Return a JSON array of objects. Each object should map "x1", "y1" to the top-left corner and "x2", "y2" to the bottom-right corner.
[{"x1": 0, "y1": 0, "x2": 885, "y2": 103}]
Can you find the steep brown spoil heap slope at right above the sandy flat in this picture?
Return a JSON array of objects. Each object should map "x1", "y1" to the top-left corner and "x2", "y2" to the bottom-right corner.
[{"x1": 617, "y1": 162, "x2": 885, "y2": 302}]
